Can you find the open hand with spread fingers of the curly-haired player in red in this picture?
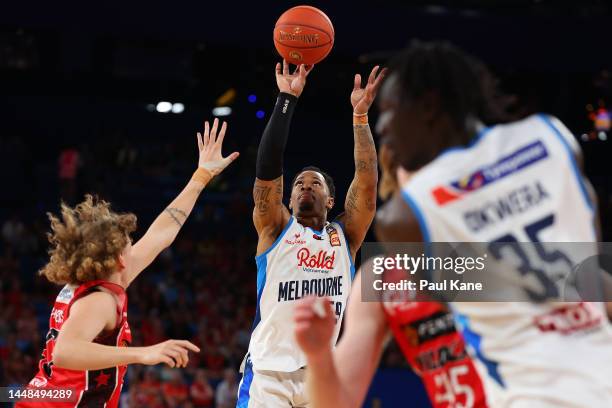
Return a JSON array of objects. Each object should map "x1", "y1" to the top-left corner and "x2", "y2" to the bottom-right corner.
[{"x1": 197, "y1": 118, "x2": 239, "y2": 176}]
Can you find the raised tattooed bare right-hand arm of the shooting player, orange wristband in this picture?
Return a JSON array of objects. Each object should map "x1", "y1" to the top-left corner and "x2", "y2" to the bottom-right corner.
[{"x1": 338, "y1": 66, "x2": 386, "y2": 258}]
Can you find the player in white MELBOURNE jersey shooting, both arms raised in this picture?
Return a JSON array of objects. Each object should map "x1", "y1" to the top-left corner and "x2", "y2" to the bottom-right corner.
[{"x1": 238, "y1": 61, "x2": 384, "y2": 407}]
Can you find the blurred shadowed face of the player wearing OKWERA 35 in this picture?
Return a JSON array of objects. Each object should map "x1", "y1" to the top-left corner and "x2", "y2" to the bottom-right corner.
[{"x1": 376, "y1": 73, "x2": 432, "y2": 171}]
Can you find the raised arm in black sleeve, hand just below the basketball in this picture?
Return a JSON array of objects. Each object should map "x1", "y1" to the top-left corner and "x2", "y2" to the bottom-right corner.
[{"x1": 253, "y1": 61, "x2": 310, "y2": 255}]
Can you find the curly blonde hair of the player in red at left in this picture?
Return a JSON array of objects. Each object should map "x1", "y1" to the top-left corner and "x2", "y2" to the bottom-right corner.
[{"x1": 39, "y1": 194, "x2": 136, "y2": 285}]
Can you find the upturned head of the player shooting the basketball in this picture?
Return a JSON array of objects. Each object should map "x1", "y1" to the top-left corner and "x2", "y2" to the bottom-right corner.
[{"x1": 289, "y1": 170, "x2": 334, "y2": 215}]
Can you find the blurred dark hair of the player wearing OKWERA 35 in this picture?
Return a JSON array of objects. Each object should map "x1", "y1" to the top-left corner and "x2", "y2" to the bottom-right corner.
[{"x1": 389, "y1": 40, "x2": 506, "y2": 127}]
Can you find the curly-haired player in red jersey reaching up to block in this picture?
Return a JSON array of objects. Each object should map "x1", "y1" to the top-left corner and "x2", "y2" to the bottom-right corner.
[{"x1": 17, "y1": 119, "x2": 238, "y2": 408}]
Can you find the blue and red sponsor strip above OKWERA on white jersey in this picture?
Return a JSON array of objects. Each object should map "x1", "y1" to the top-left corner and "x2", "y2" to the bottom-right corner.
[{"x1": 431, "y1": 141, "x2": 548, "y2": 206}]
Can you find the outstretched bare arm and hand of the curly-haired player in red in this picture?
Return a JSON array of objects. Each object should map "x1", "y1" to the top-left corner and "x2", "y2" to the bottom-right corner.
[{"x1": 127, "y1": 119, "x2": 238, "y2": 282}]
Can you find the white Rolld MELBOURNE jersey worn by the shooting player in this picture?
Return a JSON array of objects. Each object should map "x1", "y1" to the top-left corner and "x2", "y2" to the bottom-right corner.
[{"x1": 249, "y1": 217, "x2": 355, "y2": 372}]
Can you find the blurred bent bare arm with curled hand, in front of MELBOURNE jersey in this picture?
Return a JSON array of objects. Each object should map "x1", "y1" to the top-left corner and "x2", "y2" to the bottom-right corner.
[{"x1": 295, "y1": 273, "x2": 387, "y2": 408}]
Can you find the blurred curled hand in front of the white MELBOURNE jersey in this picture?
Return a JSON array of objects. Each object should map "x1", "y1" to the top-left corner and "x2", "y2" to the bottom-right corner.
[{"x1": 293, "y1": 296, "x2": 336, "y2": 358}]
